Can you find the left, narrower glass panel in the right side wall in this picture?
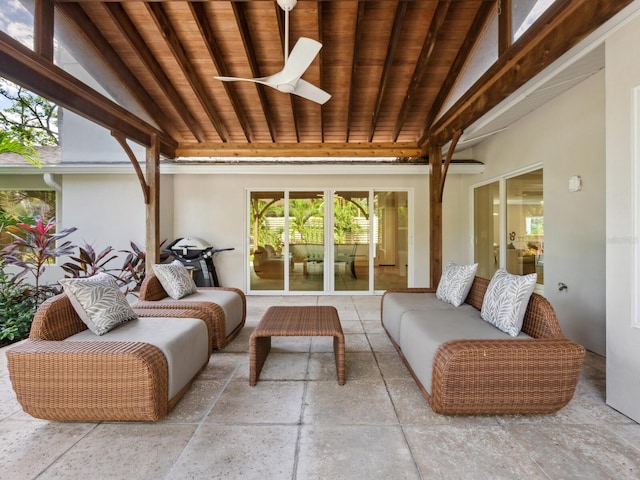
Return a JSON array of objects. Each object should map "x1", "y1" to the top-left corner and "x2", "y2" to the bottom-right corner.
[{"x1": 473, "y1": 182, "x2": 500, "y2": 278}]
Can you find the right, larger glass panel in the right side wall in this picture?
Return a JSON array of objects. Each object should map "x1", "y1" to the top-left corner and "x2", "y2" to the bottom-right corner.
[{"x1": 506, "y1": 169, "x2": 544, "y2": 284}]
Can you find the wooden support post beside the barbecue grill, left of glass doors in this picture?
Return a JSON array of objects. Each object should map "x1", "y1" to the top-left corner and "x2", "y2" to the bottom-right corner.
[{"x1": 145, "y1": 134, "x2": 160, "y2": 275}]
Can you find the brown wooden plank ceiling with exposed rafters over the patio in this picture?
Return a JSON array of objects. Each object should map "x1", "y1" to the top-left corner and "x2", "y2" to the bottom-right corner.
[{"x1": 5, "y1": 0, "x2": 631, "y2": 161}]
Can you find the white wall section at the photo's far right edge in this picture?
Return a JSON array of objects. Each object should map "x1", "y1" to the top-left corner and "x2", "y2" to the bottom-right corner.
[{"x1": 606, "y1": 13, "x2": 640, "y2": 421}]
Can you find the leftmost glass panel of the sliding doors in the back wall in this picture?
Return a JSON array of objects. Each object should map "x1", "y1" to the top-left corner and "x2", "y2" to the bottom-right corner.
[{"x1": 249, "y1": 192, "x2": 289, "y2": 290}]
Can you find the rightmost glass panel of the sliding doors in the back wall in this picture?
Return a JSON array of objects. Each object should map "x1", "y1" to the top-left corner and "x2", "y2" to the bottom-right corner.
[{"x1": 373, "y1": 192, "x2": 409, "y2": 290}]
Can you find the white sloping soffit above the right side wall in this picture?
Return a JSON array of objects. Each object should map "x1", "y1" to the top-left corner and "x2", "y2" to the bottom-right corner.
[{"x1": 443, "y1": 0, "x2": 640, "y2": 152}]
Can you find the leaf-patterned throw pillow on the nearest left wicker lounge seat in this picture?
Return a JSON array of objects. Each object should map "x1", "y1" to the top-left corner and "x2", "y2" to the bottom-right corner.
[{"x1": 59, "y1": 273, "x2": 138, "y2": 335}]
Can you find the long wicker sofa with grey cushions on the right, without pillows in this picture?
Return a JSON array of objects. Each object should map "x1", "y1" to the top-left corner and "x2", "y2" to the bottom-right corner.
[{"x1": 381, "y1": 277, "x2": 585, "y2": 414}]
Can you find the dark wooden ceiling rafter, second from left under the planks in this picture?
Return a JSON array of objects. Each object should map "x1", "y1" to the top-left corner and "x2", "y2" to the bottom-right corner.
[{"x1": 104, "y1": 2, "x2": 206, "y2": 142}]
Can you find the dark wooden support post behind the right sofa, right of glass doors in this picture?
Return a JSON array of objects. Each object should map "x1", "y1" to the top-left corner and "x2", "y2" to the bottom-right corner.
[{"x1": 429, "y1": 141, "x2": 442, "y2": 288}]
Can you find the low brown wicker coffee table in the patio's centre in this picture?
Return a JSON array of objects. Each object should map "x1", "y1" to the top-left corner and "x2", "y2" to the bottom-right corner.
[{"x1": 249, "y1": 306, "x2": 345, "y2": 386}]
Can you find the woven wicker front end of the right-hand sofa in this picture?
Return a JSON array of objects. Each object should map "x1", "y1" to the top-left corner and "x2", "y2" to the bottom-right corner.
[{"x1": 430, "y1": 338, "x2": 585, "y2": 414}]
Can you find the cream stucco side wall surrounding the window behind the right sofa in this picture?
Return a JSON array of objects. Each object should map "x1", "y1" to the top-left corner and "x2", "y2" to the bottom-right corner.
[{"x1": 452, "y1": 72, "x2": 605, "y2": 354}]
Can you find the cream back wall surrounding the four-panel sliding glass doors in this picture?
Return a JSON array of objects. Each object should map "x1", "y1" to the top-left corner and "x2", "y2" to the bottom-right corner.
[{"x1": 174, "y1": 171, "x2": 429, "y2": 291}]
